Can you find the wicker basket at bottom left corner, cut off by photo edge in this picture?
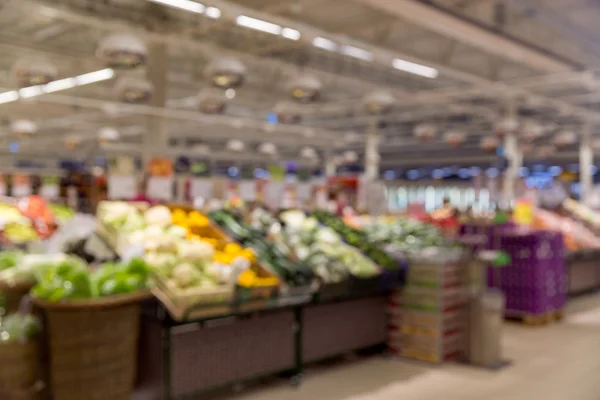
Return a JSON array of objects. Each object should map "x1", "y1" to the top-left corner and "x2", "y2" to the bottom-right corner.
[{"x1": 0, "y1": 341, "x2": 40, "y2": 390}]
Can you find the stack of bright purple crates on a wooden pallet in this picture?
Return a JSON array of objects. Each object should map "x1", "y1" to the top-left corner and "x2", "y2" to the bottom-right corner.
[{"x1": 489, "y1": 231, "x2": 567, "y2": 316}]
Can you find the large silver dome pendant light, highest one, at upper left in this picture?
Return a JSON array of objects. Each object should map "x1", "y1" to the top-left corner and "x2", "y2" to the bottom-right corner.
[{"x1": 96, "y1": 33, "x2": 148, "y2": 69}]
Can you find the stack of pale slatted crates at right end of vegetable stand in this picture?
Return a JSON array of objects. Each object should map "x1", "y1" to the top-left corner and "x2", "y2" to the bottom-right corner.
[{"x1": 388, "y1": 249, "x2": 466, "y2": 363}]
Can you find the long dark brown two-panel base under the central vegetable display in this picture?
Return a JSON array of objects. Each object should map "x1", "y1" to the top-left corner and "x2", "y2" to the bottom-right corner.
[{"x1": 134, "y1": 290, "x2": 394, "y2": 400}]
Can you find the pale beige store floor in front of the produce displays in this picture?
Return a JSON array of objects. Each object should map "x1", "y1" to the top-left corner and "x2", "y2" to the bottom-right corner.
[{"x1": 228, "y1": 295, "x2": 600, "y2": 400}]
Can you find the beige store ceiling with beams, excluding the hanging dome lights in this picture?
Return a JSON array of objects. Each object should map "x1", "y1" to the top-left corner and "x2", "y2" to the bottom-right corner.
[{"x1": 0, "y1": 0, "x2": 600, "y2": 172}]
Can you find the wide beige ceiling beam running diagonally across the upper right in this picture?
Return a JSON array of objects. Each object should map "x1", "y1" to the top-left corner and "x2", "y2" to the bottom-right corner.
[{"x1": 359, "y1": 0, "x2": 577, "y2": 72}]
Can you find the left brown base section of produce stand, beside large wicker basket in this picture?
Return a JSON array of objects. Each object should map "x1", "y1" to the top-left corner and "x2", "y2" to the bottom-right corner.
[{"x1": 134, "y1": 308, "x2": 297, "y2": 400}]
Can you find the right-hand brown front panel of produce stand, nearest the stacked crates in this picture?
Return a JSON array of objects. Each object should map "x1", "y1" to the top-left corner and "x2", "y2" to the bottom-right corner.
[{"x1": 301, "y1": 296, "x2": 387, "y2": 363}]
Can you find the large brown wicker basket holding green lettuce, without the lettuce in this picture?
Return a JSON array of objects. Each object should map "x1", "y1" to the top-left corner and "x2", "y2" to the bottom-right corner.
[{"x1": 35, "y1": 292, "x2": 148, "y2": 400}]
